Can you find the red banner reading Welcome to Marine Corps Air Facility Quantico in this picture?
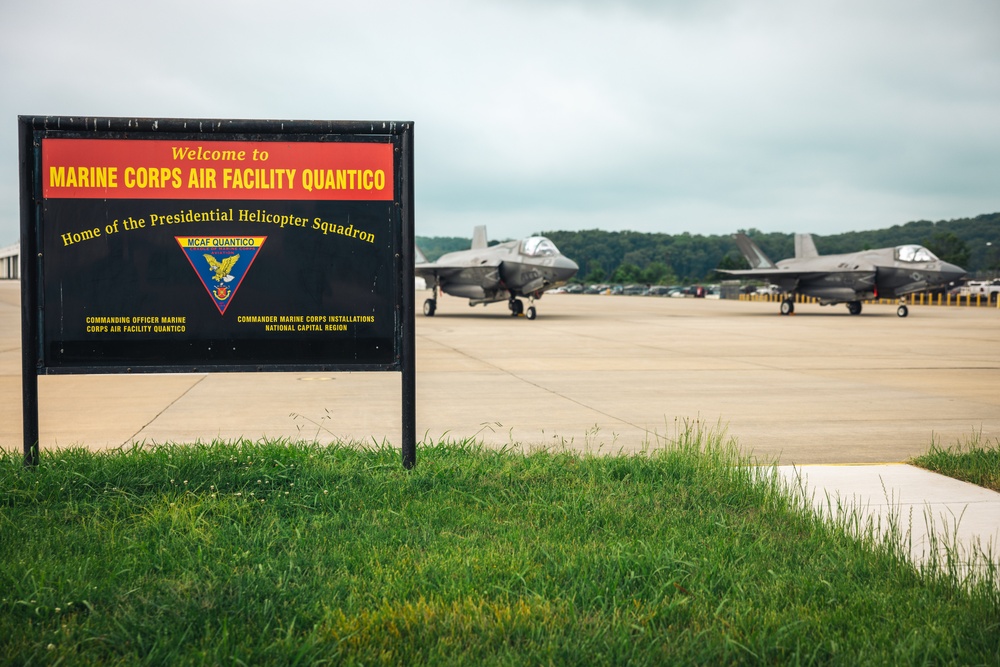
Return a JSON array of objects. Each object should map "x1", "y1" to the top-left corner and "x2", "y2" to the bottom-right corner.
[{"x1": 42, "y1": 138, "x2": 394, "y2": 201}]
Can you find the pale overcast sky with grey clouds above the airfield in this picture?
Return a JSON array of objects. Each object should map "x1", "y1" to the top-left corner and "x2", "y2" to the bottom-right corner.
[{"x1": 0, "y1": 0, "x2": 1000, "y2": 246}]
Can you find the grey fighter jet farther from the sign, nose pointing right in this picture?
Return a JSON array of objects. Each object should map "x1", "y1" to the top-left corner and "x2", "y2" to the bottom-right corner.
[{"x1": 720, "y1": 234, "x2": 966, "y2": 317}]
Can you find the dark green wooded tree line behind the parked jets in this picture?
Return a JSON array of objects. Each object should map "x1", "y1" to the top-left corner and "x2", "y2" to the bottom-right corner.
[{"x1": 416, "y1": 213, "x2": 1000, "y2": 285}]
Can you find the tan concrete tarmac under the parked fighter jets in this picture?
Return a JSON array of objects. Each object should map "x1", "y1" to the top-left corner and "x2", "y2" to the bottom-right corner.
[{"x1": 0, "y1": 281, "x2": 1000, "y2": 564}]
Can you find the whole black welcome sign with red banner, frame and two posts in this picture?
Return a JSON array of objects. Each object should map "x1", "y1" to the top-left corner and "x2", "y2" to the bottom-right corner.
[{"x1": 18, "y1": 116, "x2": 416, "y2": 468}]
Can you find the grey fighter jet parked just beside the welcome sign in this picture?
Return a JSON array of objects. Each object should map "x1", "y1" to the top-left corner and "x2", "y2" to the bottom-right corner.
[{"x1": 413, "y1": 226, "x2": 580, "y2": 320}]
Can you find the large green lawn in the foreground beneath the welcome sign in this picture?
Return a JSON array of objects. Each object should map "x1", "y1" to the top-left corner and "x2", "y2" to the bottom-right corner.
[{"x1": 0, "y1": 429, "x2": 1000, "y2": 665}]
